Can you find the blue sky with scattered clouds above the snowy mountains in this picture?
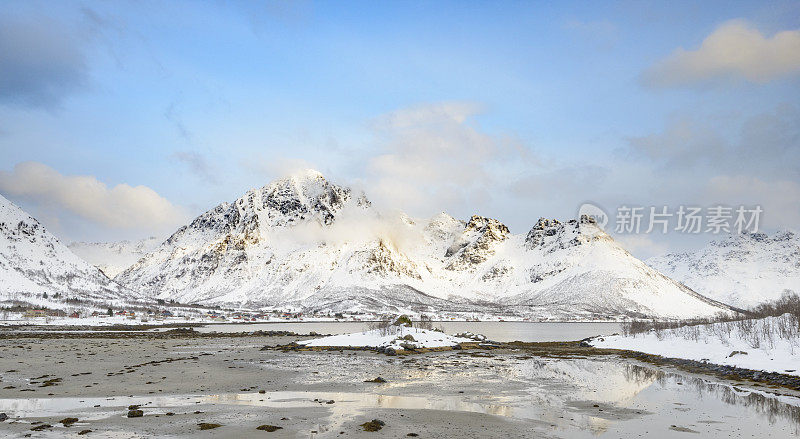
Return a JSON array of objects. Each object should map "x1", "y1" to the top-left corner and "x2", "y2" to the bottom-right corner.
[{"x1": 0, "y1": 1, "x2": 800, "y2": 255}]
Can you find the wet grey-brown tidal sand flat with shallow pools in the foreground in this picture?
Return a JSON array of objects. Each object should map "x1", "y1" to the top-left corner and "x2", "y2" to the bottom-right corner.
[{"x1": 0, "y1": 333, "x2": 800, "y2": 438}]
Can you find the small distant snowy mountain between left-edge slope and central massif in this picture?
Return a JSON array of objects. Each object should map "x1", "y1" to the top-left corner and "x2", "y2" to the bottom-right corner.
[{"x1": 67, "y1": 236, "x2": 164, "y2": 278}]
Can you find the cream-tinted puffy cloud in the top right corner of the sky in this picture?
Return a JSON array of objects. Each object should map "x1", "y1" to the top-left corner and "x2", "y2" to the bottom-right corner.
[{"x1": 643, "y1": 20, "x2": 800, "y2": 87}]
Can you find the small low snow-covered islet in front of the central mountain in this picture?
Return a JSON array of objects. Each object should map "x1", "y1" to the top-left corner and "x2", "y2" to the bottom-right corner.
[{"x1": 298, "y1": 326, "x2": 475, "y2": 351}]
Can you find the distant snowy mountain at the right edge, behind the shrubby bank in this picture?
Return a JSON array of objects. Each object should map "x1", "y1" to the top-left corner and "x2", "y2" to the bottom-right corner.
[{"x1": 647, "y1": 231, "x2": 800, "y2": 308}]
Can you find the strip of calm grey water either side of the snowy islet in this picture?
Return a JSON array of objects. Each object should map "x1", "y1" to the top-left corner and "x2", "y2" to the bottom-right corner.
[{"x1": 197, "y1": 322, "x2": 620, "y2": 342}]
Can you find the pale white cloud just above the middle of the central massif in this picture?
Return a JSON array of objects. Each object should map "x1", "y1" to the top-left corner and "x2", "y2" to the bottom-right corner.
[{"x1": 365, "y1": 102, "x2": 530, "y2": 220}]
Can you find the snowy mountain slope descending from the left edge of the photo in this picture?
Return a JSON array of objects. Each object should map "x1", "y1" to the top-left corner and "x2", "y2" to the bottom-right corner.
[{"x1": 0, "y1": 195, "x2": 138, "y2": 306}]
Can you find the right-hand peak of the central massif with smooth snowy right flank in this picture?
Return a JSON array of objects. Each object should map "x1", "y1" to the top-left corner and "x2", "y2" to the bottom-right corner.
[{"x1": 494, "y1": 217, "x2": 732, "y2": 318}]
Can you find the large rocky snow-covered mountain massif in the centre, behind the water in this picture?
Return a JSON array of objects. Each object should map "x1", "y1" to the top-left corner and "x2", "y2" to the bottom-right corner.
[{"x1": 115, "y1": 170, "x2": 728, "y2": 319}]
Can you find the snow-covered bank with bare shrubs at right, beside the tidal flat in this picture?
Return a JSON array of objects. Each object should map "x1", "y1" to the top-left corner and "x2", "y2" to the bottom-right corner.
[{"x1": 590, "y1": 314, "x2": 800, "y2": 375}]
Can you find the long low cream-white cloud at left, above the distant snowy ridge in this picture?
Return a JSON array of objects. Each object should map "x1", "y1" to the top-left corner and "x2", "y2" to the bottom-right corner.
[{"x1": 0, "y1": 162, "x2": 188, "y2": 233}]
